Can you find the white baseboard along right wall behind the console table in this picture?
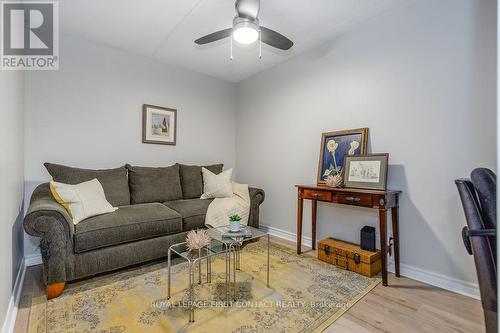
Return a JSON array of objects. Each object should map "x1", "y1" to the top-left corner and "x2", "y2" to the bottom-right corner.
[{"x1": 260, "y1": 225, "x2": 480, "y2": 299}]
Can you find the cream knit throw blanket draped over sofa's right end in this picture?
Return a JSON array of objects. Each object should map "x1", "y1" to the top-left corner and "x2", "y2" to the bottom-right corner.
[{"x1": 205, "y1": 182, "x2": 250, "y2": 228}]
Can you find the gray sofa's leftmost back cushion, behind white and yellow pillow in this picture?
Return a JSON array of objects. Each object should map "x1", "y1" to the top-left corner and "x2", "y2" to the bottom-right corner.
[{"x1": 44, "y1": 163, "x2": 130, "y2": 207}]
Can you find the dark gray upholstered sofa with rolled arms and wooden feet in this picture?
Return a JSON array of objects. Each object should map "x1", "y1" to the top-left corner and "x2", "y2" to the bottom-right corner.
[{"x1": 24, "y1": 163, "x2": 264, "y2": 298}]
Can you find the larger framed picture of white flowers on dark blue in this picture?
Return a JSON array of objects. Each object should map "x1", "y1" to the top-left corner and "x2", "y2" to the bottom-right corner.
[{"x1": 317, "y1": 127, "x2": 368, "y2": 186}]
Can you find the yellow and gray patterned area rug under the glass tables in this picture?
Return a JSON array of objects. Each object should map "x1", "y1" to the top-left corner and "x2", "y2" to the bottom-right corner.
[{"x1": 29, "y1": 240, "x2": 380, "y2": 333}]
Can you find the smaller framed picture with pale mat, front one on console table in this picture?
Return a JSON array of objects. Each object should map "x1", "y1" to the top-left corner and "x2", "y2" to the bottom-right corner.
[{"x1": 344, "y1": 153, "x2": 389, "y2": 191}]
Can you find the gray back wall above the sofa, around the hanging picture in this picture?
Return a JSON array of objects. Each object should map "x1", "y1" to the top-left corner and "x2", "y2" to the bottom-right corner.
[{"x1": 25, "y1": 35, "x2": 236, "y2": 255}]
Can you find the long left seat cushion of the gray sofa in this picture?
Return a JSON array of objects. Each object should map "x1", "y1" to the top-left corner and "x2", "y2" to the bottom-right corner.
[{"x1": 74, "y1": 203, "x2": 182, "y2": 253}]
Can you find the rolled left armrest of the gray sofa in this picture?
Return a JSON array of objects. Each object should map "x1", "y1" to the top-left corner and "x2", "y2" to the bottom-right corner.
[{"x1": 23, "y1": 183, "x2": 74, "y2": 241}]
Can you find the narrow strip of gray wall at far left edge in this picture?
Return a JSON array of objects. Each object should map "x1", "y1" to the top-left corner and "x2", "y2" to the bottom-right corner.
[{"x1": 0, "y1": 71, "x2": 24, "y2": 325}]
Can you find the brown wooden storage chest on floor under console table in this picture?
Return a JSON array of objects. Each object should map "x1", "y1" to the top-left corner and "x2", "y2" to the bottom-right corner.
[{"x1": 318, "y1": 238, "x2": 382, "y2": 277}]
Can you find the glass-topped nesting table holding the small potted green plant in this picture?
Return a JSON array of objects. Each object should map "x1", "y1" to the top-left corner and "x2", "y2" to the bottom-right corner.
[{"x1": 207, "y1": 226, "x2": 271, "y2": 301}]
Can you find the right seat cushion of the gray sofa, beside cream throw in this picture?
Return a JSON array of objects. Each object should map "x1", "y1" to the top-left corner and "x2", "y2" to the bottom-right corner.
[{"x1": 164, "y1": 199, "x2": 212, "y2": 231}]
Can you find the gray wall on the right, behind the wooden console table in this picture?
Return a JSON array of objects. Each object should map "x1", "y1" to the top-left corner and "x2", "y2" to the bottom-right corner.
[{"x1": 236, "y1": 0, "x2": 496, "y2": 292}]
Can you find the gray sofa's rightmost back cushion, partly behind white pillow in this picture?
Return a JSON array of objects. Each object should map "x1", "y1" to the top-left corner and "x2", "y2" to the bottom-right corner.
[{"x1": 179, "y1": 164, "x2": 224, "y2": 199}]
